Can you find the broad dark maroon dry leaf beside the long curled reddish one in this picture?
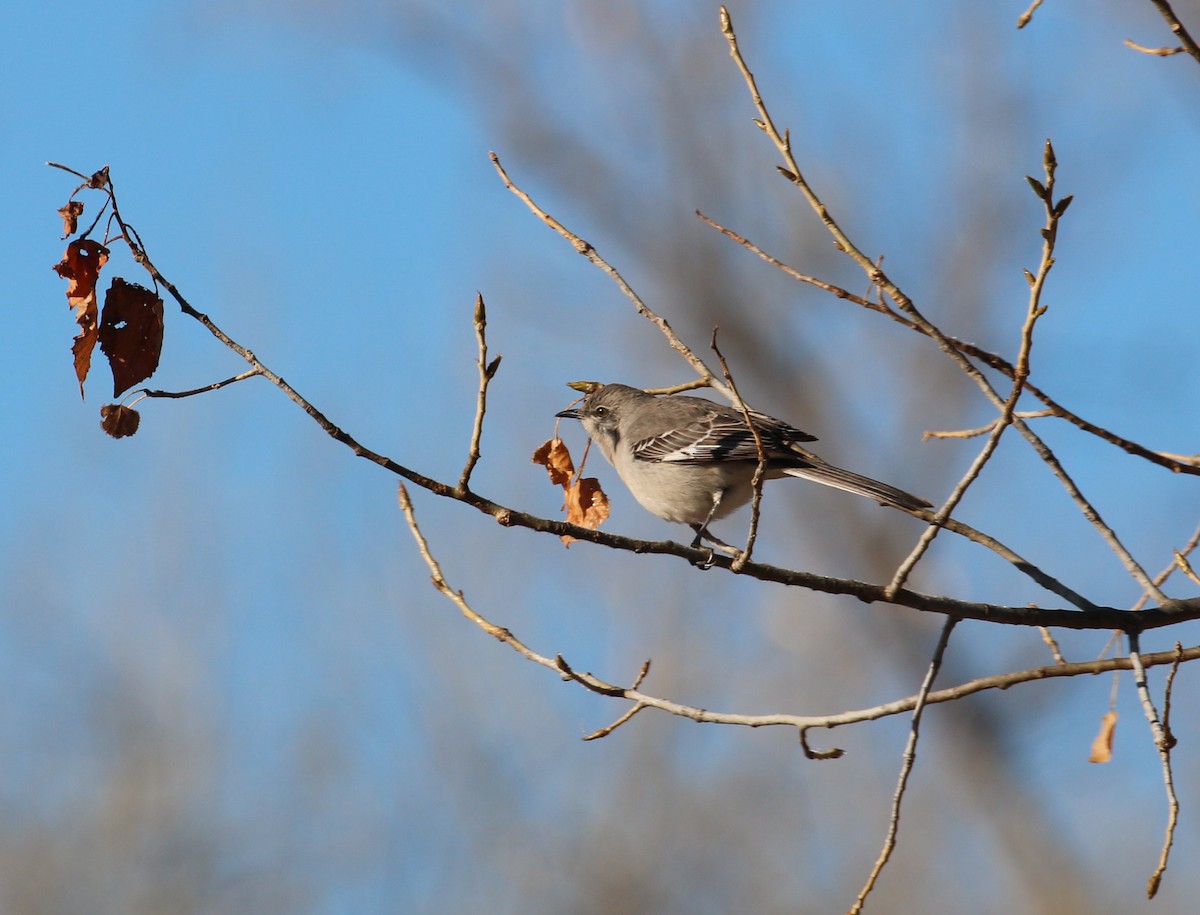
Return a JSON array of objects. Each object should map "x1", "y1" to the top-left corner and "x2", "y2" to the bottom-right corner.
[{"x1": 100, "y1": 276, "x2": 162, "y2": 397}]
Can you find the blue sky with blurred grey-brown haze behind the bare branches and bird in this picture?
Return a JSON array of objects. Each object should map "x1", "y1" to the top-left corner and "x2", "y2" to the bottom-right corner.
[{"x1": 7, "y1": 1, "x2": 1200, "y2": 911}]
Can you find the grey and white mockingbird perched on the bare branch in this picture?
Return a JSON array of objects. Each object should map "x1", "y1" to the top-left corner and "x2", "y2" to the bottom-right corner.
[{"x1": 557, "y1": 384, "x2": 931, "y2": 546}]
